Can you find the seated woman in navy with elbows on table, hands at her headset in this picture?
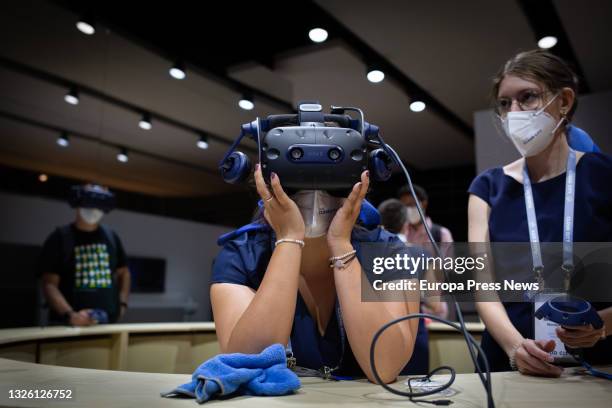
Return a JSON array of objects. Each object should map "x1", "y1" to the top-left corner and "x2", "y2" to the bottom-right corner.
[{"x1": 211, "y1": 165, "x2": 419, "y2": 382}]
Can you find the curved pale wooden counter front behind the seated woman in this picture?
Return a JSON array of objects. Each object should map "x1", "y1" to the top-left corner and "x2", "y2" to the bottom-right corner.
[{"x1": 0, "y1": 322, "x2": 484, "y2": 374}]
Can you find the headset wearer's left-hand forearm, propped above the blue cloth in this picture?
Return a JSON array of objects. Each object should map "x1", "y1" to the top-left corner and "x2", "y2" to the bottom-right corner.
[{"x1": 224, "y1": 243, "x2": 302, "y2": 353}]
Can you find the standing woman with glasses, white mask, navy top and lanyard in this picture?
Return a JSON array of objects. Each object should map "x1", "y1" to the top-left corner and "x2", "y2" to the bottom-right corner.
[{"x1": 468, "y1": 50, "x2": 612, "y2": 376}]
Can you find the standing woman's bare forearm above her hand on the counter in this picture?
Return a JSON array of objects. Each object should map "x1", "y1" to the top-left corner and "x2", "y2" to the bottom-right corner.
[{"x1": 476, "y1": 302, "x2": 523, "y2": 355}]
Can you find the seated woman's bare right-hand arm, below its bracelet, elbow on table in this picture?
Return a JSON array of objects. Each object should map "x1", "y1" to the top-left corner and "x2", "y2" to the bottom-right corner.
[{"x1": 334, "y1": 247, "x2": 418, "y2": 383}]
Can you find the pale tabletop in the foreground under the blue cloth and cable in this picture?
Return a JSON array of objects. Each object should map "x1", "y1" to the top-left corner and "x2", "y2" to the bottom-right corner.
[{"x1": 0, "y1": 359, "x2": 612, "y2": 408}]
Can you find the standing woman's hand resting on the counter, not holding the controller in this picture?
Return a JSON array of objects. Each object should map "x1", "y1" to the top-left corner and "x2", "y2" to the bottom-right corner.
[{"x1": 510, "y1": 339, "x2": 563, "y2": 377}]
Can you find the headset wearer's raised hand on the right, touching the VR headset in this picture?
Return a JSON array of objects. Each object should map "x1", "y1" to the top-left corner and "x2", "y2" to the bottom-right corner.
[{"x1": 327, "y1": 171, "x2": 370, "y2": 255}]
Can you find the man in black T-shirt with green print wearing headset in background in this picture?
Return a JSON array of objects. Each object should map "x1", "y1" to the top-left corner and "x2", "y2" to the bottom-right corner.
[{"x1": 39, "y1": 184, "x2": 130, "y2": 326}]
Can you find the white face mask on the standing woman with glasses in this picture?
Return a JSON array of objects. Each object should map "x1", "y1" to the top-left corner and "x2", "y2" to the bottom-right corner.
[{"x1": 502, "y1": 94, "x2": 564, "y2": 157}]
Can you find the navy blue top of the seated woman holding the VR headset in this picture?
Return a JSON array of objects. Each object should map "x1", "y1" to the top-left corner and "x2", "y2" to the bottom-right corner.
[{"x1": 211, "y1": 224, "x2": 427, "y2": 377}]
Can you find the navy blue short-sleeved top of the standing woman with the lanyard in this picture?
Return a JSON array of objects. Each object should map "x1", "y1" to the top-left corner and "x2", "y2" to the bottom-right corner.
[{"x1": 468, "y1": 153, "x2": 612, "y2": 371}]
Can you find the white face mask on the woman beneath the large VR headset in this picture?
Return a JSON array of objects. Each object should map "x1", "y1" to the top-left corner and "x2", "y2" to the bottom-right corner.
[{"x1": 291, "y1": 190, "x2": 344, "y2": 238}]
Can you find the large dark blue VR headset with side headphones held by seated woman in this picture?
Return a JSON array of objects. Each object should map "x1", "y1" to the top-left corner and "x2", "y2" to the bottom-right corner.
[{"x1": 219, "y1": 102, "x2": 392, "y2": 195}]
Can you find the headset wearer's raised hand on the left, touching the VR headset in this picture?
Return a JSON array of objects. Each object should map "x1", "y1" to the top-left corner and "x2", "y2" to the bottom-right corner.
[{"x1": 255, "y1": 163, "x2": 305, "y2": 240}]
